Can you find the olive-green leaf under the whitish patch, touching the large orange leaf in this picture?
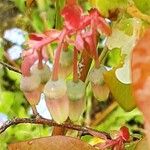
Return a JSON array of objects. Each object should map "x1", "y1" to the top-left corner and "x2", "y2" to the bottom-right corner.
[{"x1": 104, "y1": 69, "x2": 136, "y2": 111}]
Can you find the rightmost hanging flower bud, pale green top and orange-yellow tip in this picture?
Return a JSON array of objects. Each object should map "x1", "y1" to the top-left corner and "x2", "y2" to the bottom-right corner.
[{"x1": 89, "y1": 66, "x2": 110, "y2": 101}]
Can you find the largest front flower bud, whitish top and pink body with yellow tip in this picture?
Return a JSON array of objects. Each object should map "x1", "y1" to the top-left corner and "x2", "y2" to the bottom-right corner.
[{"x1": 44, "y1": 79, "x2": 69, "y2": 123}]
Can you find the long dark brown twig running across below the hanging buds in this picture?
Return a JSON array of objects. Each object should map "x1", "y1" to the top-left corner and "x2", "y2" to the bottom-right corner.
[{"x1": 0, "y1": 117, "x2": 111, "y2": 139}]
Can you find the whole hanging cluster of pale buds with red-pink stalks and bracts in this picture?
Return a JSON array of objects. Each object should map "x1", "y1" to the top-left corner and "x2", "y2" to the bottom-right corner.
[{"x1": 20, "y1": 0, "x2": 111, "y2": 123}]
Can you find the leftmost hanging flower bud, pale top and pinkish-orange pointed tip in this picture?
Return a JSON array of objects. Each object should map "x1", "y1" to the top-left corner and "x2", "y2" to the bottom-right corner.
[{"x1": 20, "y1": 74, "x2": 41, "y2": 106}]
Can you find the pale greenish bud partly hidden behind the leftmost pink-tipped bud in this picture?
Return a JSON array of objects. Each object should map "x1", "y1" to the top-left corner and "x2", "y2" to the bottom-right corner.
[{"x1": 31, "y1": 64, "x2": 51, "y2": 84}]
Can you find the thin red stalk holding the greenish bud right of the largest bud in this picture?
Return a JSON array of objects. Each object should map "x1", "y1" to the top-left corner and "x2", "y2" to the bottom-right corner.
[{"x1": 73, "y1": 48, "x2": 78, "y2": 82}]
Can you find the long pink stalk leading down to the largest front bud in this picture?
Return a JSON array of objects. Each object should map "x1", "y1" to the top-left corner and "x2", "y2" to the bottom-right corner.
[{"x1": 52, "y1": 29, "x2": 66, "y2": 81}]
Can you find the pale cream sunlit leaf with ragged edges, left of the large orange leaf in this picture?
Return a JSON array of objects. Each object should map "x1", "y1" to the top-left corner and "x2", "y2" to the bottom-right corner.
[{"x1": 106, "y1": 18, "x2": 141, "y2": 84}]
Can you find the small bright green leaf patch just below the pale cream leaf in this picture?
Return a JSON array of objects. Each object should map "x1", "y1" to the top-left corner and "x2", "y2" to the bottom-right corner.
[{"x1": 105, "y1": 48, "x2": 121, "y2": 67}]
